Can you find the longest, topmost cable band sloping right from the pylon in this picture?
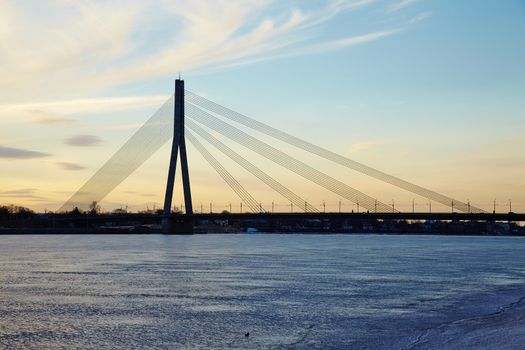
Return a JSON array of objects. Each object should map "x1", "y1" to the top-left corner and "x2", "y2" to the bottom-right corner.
[{"x1": 186, "y1": 90, "x2": 484, "y2": 213}]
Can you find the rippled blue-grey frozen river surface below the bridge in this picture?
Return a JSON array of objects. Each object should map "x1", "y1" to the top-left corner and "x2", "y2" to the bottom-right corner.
[{"x1": 0, "y1": 234, "x2": 525, "y2": 349}]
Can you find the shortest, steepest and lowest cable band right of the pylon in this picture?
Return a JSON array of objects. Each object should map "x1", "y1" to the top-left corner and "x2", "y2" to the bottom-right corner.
[{"x1": 186, "y1": 130, "x2": 260, "y2": 213}]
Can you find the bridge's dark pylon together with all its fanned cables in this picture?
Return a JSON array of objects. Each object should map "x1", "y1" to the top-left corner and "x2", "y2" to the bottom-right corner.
[{"x1": 61, "y1": 79, "x2": 516, "y2": 234}]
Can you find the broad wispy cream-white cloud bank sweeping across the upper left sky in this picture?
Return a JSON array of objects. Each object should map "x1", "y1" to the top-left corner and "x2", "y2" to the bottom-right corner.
[{"x1": 0, "y1": 0, "x2": 398, "y2": 103}]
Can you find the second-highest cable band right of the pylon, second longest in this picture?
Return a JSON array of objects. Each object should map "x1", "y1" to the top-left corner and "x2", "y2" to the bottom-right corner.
[{"x1": 186, "y1": 103, "x2": 392, "y2": 212}]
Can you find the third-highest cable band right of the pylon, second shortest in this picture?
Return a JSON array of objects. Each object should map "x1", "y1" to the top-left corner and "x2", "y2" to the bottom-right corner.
[{"x1": 186, "y1": 119, "x2": 319, "y2": 212}]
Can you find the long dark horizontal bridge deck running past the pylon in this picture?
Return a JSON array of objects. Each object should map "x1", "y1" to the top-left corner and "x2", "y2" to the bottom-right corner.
[{"x1": 56, "y1": 212, "x2": 525, "y2": 223}]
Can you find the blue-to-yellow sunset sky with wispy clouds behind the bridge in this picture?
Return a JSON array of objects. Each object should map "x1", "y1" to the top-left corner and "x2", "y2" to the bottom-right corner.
[{"x1": 0, "y1": 0, "x2": 525, "y2": 212}]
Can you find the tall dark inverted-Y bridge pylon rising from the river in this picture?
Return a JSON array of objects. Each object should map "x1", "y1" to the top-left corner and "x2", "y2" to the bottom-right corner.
[{"x1": 162, "y1": 77, "x2": 193, "y2": 233}]
